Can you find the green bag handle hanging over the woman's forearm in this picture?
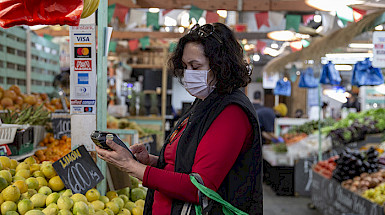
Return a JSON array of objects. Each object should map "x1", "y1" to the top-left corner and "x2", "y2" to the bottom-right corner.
[{"x1": 190, "y1": 175, "x2": 247, "y2": 215}]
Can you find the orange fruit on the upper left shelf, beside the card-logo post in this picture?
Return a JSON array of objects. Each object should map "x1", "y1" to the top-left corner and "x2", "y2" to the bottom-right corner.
[{"x1": 0, "y1": 85, "x2": 70, "y2": 112}]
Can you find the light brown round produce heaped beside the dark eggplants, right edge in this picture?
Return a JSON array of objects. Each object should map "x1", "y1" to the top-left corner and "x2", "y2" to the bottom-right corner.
[{"x1": 341, "y1": 169, "x2": 385, "y2": 195}]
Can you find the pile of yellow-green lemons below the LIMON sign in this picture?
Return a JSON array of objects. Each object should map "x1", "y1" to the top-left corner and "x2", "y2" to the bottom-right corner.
[{"x1": 0, "y1": 156, "x2": 145, "y2": 215}]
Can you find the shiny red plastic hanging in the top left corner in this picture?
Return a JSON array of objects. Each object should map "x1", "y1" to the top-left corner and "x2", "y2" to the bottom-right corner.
[{"x1": 0, "y1": 0, "x2": 83, "y2": 28}]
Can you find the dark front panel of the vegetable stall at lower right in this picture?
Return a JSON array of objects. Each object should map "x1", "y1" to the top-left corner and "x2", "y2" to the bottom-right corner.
[{"x1": 311, "y1": 172, "x2": 384, "y2": 215}]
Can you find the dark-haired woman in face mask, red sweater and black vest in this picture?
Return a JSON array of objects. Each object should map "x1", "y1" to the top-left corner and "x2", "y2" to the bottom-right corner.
[{"x1": 96, "y1": 23, "x2": 262, "y2": 214}]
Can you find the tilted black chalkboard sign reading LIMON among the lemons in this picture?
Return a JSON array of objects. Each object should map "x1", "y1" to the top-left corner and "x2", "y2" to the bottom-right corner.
[{"x1": 53, "y1": 145, "x2": 104, "y2": 194}]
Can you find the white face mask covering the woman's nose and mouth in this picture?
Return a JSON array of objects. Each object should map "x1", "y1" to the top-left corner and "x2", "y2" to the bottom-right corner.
[{"x1": 183, "y1": 69, "x2": 215, "y2": 99}]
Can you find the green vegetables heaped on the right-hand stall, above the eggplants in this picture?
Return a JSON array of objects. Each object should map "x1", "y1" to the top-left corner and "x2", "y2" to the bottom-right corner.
[{"x1": 322, "y1": 108, "x2": 385, "y2": 145}]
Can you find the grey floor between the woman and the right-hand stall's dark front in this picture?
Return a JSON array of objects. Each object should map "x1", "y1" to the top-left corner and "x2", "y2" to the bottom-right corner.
[{"x1": 263, "y1": 184, "x2": 322, "y2": 215}]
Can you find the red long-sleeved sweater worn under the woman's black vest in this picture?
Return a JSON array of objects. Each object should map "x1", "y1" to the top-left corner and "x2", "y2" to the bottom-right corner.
[{"x1": 143, "y1": 105, "x2": 253, "y2": 215}]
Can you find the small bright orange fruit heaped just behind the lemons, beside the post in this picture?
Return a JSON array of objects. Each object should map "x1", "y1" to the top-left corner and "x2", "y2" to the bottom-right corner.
[{"x1": 35, "y1": 133, "x2": 71, "y2": 162}]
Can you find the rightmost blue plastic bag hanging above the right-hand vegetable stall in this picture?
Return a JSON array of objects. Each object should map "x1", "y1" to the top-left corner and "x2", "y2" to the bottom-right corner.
[{"x1": 352, "y1": 58, "x2": 384, "y2": 87}]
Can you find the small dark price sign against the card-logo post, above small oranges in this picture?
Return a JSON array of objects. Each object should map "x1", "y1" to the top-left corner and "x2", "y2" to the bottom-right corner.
[{"x1": 51, "y1": 113, "x2": 71, "y2": 139}]
